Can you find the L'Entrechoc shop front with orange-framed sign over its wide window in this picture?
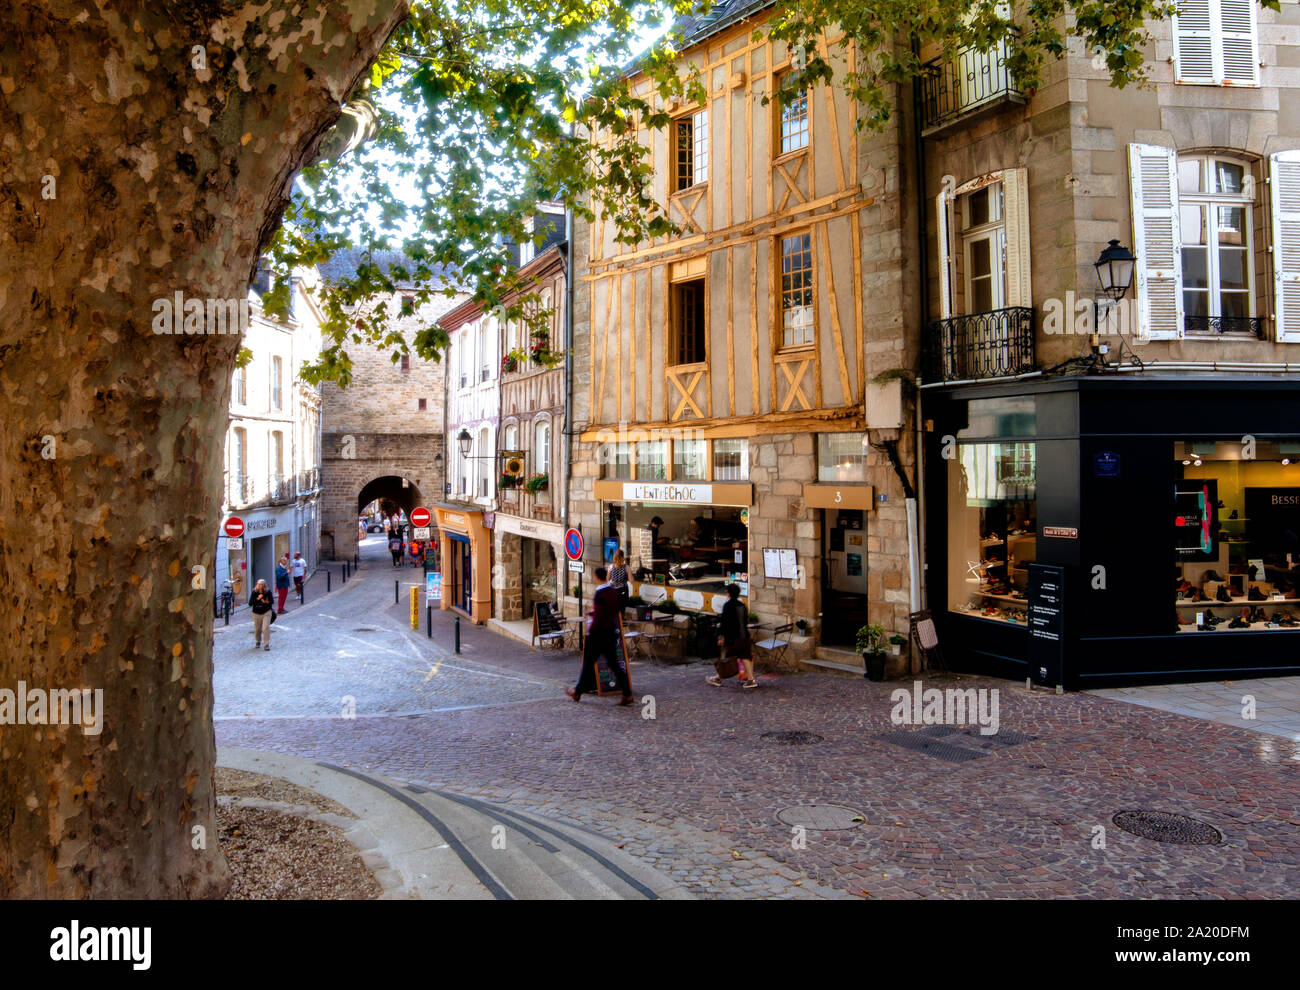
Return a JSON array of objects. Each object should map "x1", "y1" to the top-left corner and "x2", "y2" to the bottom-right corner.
[{"x1": 595, "y1": 481, "x2": 754, "y2": 613}]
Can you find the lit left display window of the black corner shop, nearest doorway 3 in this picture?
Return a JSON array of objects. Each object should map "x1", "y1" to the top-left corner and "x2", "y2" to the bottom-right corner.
[{"x1": 948, "y1": 443, "x2": 1037, "y2": 625}]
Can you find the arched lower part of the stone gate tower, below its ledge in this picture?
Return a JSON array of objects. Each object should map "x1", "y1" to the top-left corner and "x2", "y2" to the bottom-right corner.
[{"x1": 321, "y1": 431, "x2": 443, "y2": 560}]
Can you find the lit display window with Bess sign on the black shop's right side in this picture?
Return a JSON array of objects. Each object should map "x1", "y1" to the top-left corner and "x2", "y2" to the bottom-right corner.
[{"x1": 1171, "y1": 440, "x2": 1300, "y2": 633}]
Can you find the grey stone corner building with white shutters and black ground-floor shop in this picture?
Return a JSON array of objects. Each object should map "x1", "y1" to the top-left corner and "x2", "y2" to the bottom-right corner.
[{"x1": 917, "y1": 0, "x2": 1300, "y2": 686}]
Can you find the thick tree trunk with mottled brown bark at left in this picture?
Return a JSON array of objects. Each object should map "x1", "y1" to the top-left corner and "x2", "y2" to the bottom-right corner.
[{"x1": 0, "y1": 0, "x2": 407, "y2": 898}]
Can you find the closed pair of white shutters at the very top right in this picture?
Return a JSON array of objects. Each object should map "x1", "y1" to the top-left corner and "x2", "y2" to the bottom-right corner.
[{"x1": 1173, "y1": 0, "x2": 1260, "y2": 86}]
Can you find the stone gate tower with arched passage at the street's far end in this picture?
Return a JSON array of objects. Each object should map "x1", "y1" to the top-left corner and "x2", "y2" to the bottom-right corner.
[{"x1": 321, "y1": 251, "x2": 464, "y2": 560}]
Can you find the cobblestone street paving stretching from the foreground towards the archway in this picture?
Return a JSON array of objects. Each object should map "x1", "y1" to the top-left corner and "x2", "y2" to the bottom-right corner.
[{"x1": 217, "y1": 540, "x2": 1300, "y2": 898}]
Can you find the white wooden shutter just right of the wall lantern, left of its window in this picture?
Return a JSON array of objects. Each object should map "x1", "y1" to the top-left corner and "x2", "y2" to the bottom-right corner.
[{"x1": 1128, "y1": 144, "x2": 1183, "y2": 340}]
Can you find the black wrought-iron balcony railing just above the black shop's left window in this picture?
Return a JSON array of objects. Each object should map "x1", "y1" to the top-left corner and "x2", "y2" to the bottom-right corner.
[{"x1": 922, "y1": 307, "x2": 1035, "y2": 382}]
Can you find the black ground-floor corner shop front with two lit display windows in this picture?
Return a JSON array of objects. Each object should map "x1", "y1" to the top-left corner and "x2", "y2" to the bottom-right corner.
[{"x1": 923, "y1": 375, "x2": 1300, "y2": 689}]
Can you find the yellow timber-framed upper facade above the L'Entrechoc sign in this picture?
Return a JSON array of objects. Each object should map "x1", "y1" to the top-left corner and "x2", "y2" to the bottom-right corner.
[{"x1": 576, "y1": 9, "x2": 876, "y2": 440}]
